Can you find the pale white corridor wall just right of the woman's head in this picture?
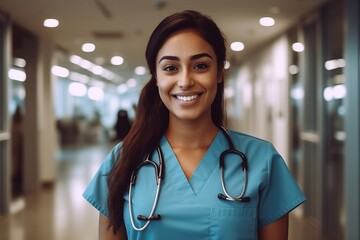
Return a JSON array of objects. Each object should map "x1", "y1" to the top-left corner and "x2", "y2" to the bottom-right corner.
[{"x1": 227, "y1": 36, "x2": 290, "y2": 163}]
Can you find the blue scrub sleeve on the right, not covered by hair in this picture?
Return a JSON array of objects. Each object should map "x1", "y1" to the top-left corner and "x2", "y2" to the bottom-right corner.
[{"x1": 259, "y1": 144, "x2": 306, "y2": 228}]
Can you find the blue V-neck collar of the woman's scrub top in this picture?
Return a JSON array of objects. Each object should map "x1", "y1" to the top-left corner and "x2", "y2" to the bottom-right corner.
[{"x1": 160, "y1": 130, "x2": 226, "y2": 196}]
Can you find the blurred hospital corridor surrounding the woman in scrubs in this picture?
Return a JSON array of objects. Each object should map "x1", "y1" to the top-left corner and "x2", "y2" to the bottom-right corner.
[{"x1": 0, "y1": 0, "x2": 360, "y2": 240}]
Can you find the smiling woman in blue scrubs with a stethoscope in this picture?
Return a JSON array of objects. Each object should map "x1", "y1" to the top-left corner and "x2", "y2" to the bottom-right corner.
[{"x1": 84, "y1": 11, "x2": 305, "y2": 240}]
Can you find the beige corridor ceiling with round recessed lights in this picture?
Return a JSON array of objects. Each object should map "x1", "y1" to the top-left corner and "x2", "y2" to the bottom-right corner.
[{"x1": 0, "y1": 0, "x2": 326, "y2": 84}]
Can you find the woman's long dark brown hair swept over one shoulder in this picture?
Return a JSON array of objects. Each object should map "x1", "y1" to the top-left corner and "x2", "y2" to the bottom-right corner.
[{"x1": 108, "y1": 10, "x2": 226, "y2": 232}]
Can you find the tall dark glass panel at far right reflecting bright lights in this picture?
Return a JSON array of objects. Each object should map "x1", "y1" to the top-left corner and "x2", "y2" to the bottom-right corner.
[{"x1": 322, "y1": 1, "x2": 346, "y2": 239}]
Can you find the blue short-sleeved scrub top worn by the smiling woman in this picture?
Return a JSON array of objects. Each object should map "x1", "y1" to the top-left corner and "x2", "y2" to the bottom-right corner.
[{"x1": 83, "y1": 131, "x2": 305, "y2": 240}]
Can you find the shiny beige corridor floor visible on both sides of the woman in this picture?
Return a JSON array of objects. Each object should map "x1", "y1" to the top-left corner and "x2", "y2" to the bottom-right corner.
[{"x1": 0, "y1": 142, "x2": 325, "y2": 240}]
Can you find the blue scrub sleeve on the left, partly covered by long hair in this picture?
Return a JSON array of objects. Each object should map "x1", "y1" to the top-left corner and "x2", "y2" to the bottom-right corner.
[{"x1": 83, "y1": 144, "x2": 121, "y2": 216}]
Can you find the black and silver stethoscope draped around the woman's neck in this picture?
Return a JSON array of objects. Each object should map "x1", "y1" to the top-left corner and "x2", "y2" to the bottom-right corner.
[{"x1": 129, "y1": 126, "x2": 250, "y2": 231}]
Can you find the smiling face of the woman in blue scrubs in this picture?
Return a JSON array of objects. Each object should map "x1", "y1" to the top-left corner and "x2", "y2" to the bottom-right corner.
[{"x1": 156, "y1": 29, "x2": 222, "y2": 124}]
